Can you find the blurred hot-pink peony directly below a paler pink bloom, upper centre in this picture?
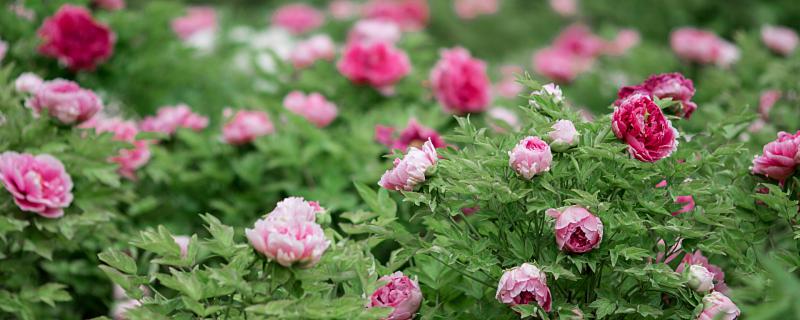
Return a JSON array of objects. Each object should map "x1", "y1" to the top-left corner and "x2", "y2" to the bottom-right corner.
[{"x1": 336, "y1": 42, "x2": 411, "y2": 90}]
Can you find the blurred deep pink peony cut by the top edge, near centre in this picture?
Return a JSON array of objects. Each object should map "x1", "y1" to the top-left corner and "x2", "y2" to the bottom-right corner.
[{"x1": 364, "y1": 0, "x2": 428, "y2": 31}]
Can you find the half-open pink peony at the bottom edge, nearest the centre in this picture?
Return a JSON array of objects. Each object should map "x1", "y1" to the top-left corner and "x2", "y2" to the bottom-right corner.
[{"x1": 368, "y1": 271, "x2": 422, "y2": 320}]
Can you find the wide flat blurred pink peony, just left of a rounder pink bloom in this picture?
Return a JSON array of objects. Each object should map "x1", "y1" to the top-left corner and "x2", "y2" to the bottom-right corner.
[{"x1": 140, "y1": 104, "x2": 208, "y2": 135}]
